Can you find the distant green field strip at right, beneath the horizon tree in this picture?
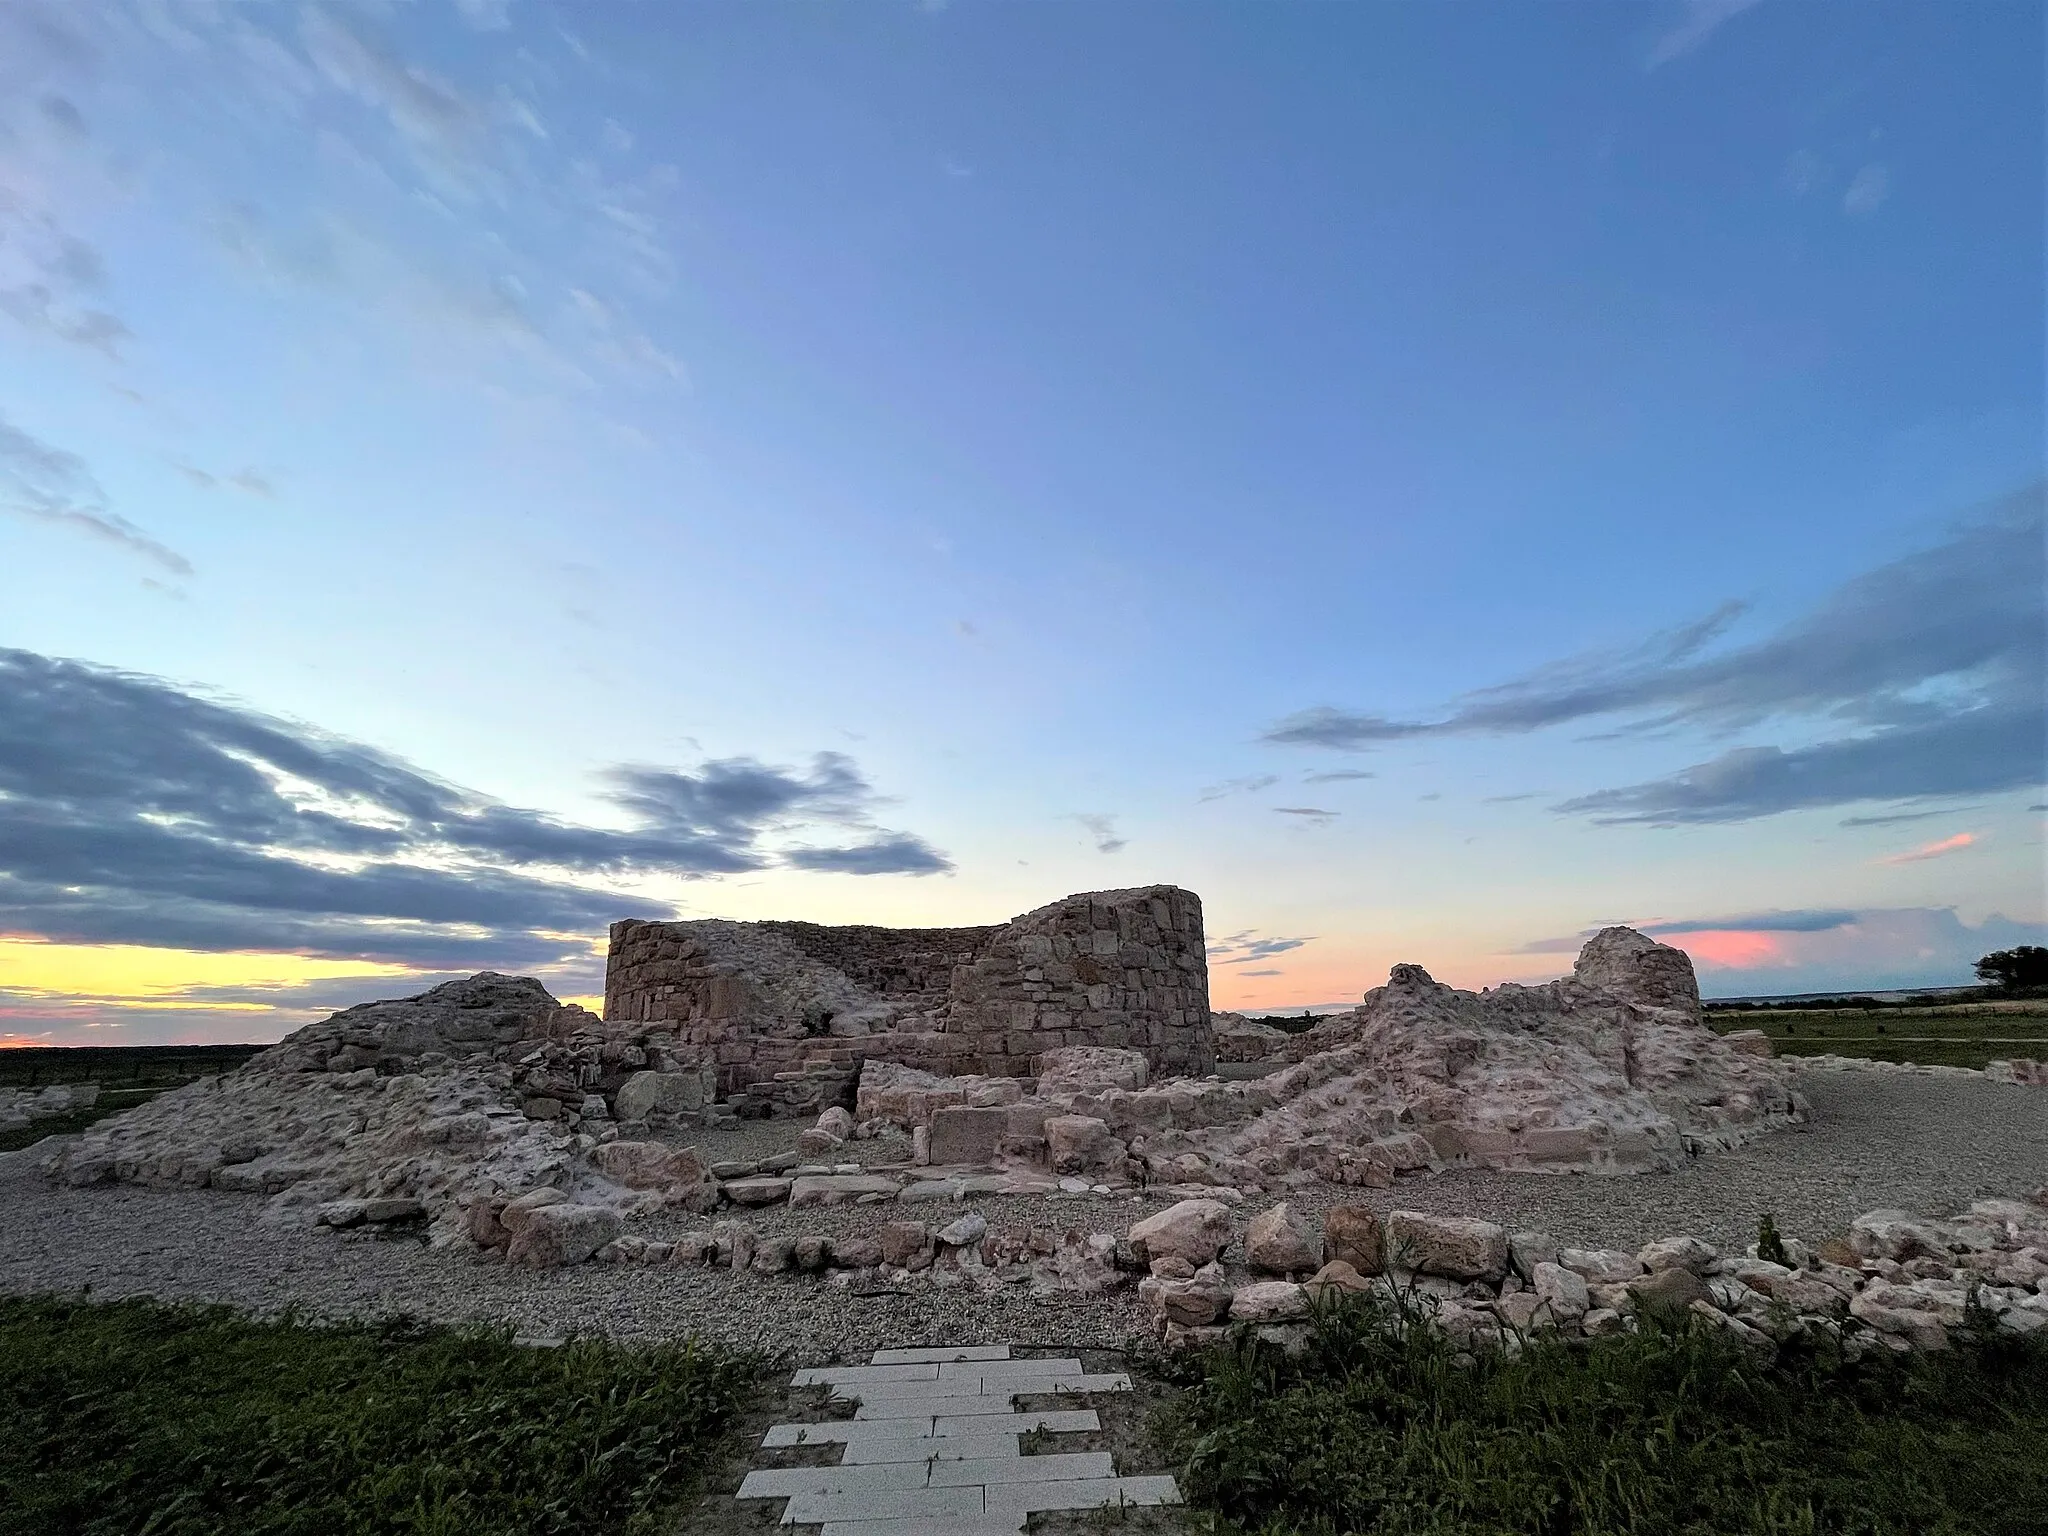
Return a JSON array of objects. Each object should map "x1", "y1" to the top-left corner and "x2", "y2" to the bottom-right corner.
[{"x1": 1706, "y1": 997, "x2": 2048, "y2": 1067}]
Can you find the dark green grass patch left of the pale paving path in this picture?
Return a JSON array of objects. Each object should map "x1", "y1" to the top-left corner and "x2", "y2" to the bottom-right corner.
[{"x1": 0, "y1": 1296, "x2": 758, "y2": 1536}]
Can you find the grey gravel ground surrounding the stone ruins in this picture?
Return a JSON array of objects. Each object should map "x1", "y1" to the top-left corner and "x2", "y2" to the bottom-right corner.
[{"x1": 0, "y1": 1071, "x2": 2048, "y2": 1364}]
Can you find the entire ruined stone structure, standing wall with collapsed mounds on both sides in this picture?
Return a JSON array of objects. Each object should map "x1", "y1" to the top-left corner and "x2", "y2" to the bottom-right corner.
[{"x1": 41, "y1": 887, "x2": 1875, "y2": 1278}]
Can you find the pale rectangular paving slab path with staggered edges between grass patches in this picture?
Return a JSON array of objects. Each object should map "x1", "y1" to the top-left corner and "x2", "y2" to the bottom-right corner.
[{"x1": 739, "y1": 1343, "x2": 1180, "y2": 1536}]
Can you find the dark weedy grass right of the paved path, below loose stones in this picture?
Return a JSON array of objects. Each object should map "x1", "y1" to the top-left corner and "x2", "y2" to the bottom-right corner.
[{"x1": 1153, "y1": 1298, "x2": 2048, "y2": 1536}]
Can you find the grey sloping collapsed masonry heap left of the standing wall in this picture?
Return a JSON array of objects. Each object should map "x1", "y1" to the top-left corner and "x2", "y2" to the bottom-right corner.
[{"x1": 45, "y1": 971, "x2": 715, "y2": 1241}]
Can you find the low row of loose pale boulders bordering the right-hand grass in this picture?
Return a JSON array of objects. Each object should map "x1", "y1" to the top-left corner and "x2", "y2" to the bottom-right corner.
[{"x1": 1128, "y1": 1190, "x2": 2048, "y2": 1352}]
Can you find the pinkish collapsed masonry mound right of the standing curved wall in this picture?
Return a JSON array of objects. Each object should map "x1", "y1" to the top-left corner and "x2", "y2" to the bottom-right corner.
[{"x1": 854, "y1": 928, "x2": 1806, "y2": 1190}]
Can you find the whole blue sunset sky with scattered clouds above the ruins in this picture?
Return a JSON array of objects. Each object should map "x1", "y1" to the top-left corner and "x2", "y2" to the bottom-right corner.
[{"x1": 0, "y1": 0, "x2": 2048, "y2": 1044}]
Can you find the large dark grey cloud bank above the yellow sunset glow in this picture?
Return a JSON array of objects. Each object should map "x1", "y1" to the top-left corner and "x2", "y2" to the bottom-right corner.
[{"x1": 0, "y1": 649, "x2": 948, "y2": 969}]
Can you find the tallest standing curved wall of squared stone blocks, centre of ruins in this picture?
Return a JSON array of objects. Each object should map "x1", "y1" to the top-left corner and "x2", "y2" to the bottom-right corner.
[{"x1": 604, "y1": 885, "x2": 1217, "y2": 1112}]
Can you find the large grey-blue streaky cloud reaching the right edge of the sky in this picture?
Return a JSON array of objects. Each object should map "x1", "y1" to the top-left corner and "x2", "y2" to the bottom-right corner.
[{"x1": 1266, "y1": 485, "x2": 2048, "y2": 823}]
